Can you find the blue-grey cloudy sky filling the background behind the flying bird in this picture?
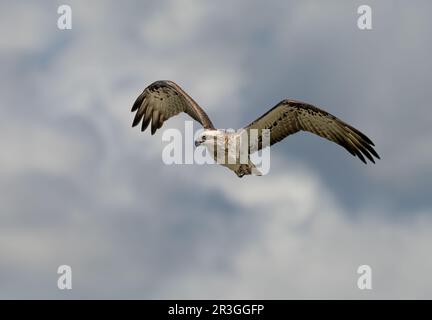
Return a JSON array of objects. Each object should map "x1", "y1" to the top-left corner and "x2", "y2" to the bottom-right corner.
[{"x1": 0, "y1": 0, "x2": 432, "y2": 299}]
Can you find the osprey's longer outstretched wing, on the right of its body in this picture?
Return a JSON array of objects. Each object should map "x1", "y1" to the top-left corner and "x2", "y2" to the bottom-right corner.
[{"x1": 244, "y1": 100, "x2": 380, "y2": 163}]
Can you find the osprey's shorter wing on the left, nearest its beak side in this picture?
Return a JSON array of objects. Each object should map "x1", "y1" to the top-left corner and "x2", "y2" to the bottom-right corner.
[{"x1": 131, "y1": 80, "x2": 214, "y2": 135}]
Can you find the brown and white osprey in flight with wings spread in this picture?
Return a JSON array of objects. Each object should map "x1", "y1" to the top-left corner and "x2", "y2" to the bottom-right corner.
[{"x1": 131, "y1": 80, "x2": 380, "y2": 177}]
